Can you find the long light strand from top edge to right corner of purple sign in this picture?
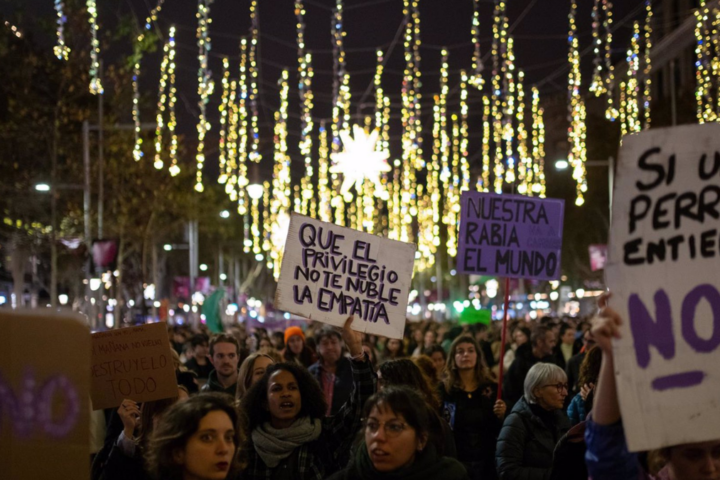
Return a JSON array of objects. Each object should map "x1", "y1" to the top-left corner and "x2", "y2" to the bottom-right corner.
[{"x1": 568, "y1": 0, "x2": 587, "y2": 206}]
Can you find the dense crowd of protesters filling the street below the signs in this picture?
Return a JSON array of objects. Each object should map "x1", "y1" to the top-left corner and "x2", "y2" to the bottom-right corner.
[{"x1": 92, "y1": 297, "x2": 720, "y2": 480}]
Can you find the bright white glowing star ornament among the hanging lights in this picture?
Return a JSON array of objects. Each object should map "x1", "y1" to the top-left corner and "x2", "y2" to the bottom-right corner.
[{"x1": 330, "y1": 125, "x2": 391, "y2": 197}]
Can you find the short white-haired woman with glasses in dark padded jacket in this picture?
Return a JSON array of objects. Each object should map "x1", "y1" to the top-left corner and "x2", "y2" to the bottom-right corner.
[{"x1": 496, "y1": 363, "x2": 570, "y2": 480}]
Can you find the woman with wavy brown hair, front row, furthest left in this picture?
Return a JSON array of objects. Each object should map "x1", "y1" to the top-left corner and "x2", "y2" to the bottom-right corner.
[{"x1": 146, "y1": 393, "x2": 241, "y2": 480}]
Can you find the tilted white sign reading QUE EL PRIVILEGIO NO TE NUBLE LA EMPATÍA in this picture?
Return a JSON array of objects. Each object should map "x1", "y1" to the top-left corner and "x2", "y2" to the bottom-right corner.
[{"x1": 275, "y1": 213, "x2": 416, "y2": 338}]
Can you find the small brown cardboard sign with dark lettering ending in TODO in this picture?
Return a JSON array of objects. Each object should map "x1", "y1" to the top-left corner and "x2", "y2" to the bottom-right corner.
[{"x1": 91, "y1": 323, "x2": 178, "y2": 410}]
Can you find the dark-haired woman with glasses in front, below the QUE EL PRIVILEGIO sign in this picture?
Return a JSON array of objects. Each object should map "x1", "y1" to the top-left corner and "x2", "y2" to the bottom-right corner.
[{"x1": 330, "y1": 386, "x2": 468, "y2": 480}]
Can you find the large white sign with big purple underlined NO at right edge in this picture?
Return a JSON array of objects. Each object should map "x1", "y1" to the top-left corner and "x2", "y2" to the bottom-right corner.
[{"x1": 605, "y1": 124, "x2": 720, "y2": 451}]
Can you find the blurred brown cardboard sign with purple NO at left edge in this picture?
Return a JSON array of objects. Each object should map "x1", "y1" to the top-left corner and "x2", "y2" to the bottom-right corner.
[{"x1": 0, "y1": 310, "x2": 90, "y2": 480}]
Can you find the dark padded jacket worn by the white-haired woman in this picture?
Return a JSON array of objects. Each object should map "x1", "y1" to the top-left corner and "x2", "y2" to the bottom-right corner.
[{"x1": 495, "y1": 398, "x2": 570, "y2": 480}]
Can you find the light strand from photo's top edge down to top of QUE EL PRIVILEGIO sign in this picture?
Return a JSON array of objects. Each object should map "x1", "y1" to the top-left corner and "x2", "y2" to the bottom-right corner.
[{"x1": 295, "y1": 0, "x2": 315, "y2": 215}]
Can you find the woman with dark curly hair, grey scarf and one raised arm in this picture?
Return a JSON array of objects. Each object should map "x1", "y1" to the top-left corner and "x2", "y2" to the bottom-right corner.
[{"x1": 241, "y1": 316, "x2": 375, "y2": 480}]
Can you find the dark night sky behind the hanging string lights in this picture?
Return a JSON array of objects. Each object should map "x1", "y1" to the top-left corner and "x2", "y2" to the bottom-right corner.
[{"x1": 0, "y1": 0, "x2": 644, "y2": 195}]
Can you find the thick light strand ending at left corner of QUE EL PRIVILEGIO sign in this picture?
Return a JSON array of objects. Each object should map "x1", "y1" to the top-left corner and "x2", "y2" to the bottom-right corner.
[{"x1": 268, "y1": 70, "x2": 291, "y2": 278}]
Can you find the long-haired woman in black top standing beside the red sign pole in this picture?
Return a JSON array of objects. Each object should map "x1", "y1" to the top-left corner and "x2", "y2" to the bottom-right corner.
[{"x1": 440, "y1": 335, "x2": 506, "y2": 480}]
